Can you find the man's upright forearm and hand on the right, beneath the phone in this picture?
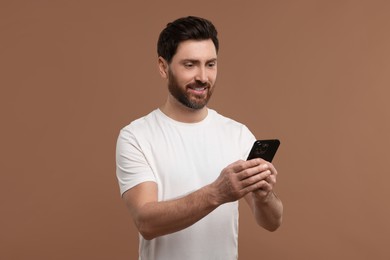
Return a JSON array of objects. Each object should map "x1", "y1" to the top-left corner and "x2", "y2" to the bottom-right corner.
[{"x1": 245, "y1": 160, "x2": 283, "y2": 231}]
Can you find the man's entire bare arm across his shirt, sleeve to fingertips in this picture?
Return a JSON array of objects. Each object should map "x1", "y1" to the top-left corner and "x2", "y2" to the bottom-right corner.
[{"x1": 123, "y1": 160, "x2": 269, "y2": 239}]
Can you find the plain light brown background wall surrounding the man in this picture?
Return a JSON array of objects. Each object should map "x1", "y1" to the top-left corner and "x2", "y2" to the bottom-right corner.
[{"x1": 0, "y1": 0, "x2": 390, "y2": 260}]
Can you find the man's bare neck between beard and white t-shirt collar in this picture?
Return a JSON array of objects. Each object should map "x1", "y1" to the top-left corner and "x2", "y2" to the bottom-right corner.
[{"x1": 160, "y1": 98, "x2": 207, "y2": 123}]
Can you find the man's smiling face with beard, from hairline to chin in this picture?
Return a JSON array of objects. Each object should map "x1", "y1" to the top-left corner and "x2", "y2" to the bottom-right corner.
[{"x1": 168, "y1": 40, "x2": 217, "y2": 109}]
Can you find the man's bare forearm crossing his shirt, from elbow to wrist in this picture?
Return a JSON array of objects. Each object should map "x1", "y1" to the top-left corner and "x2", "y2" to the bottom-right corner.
[{"x1": 134, "y1": 186, "x2": 219, "y2": 239}]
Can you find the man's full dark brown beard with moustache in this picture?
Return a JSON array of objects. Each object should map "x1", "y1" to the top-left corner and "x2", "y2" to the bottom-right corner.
[{"x1": 168, "y1": 71, "x2": 213, "y2": 110}]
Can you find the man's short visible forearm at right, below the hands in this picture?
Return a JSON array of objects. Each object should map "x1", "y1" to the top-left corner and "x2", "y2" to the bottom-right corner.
[{"x1": 252, "y1": 192, "x2": 283, "y2": 231}]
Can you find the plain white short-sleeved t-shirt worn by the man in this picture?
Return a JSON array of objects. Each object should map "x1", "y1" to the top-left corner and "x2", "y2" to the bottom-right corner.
[{"x1": 116, "y1": 109, "x2": 255, "y2": 260}]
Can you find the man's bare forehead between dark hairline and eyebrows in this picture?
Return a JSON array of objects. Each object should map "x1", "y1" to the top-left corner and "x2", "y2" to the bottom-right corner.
[{"x1": 173, "y1": 39, "x2": 217, "y2": 60}]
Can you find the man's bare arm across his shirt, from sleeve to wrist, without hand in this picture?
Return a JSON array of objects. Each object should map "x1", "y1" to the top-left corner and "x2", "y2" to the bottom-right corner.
[{"x1": 123, "y1": 182, "x2": 218, "y2": 240}]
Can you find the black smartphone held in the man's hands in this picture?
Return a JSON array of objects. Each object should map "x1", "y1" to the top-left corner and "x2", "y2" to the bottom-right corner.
[{"x1": 247, "y1": 139, "x2": 280, "y2": 162}]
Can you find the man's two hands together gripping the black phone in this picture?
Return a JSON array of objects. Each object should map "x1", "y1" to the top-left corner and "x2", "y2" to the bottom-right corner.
[{"x1": 211, "y1": 158, "x2": 277, "y2": 204}]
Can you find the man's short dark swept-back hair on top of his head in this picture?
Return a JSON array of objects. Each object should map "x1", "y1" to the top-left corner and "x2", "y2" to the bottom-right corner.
[{"x1": 157, "y1": 16, "x2": 219, "y2": 63}]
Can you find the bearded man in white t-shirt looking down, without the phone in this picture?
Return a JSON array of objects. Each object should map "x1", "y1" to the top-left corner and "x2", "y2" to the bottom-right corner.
[{"x1": 116, "y1": 16, "x2": 283, "y2": 260}]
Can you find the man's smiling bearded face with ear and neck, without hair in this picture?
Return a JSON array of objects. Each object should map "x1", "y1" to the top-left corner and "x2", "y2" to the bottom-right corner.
[{"x1": 159, "y1": 39, "x2": 217, "y2": 123}]
